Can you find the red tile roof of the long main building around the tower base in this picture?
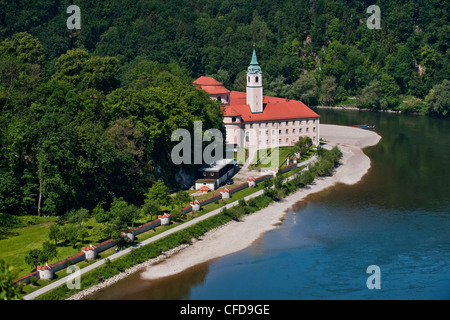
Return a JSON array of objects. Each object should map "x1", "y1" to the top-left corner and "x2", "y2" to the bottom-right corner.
[{"x1": 225, "y1": 91, "x2": 320, "y2": 122}]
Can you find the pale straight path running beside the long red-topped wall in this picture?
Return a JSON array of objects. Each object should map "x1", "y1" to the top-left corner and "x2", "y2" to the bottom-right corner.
[{"x1": 23, "y1": 156, "x2": 316, "y2": 300}]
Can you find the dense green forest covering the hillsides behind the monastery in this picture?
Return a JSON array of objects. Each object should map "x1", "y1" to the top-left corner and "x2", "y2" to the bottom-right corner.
[{"x1": 0, "y1": 0, "x2": 450, "y2": 216}]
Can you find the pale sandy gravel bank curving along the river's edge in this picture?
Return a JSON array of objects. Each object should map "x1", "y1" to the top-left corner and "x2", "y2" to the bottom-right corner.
[{"x1": 71, "y1": 125, "x2": 381, "y2": 299}]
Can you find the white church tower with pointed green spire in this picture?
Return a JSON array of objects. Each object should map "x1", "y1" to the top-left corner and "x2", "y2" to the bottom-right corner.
[{"x1": 247, "y1": 49, "x2": 264, "y2": 113}]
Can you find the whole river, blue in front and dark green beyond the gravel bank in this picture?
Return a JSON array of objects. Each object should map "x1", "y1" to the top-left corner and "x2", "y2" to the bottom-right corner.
[{"x1": 90, "y1": 109, "x2": 450, "y2": 300}]
